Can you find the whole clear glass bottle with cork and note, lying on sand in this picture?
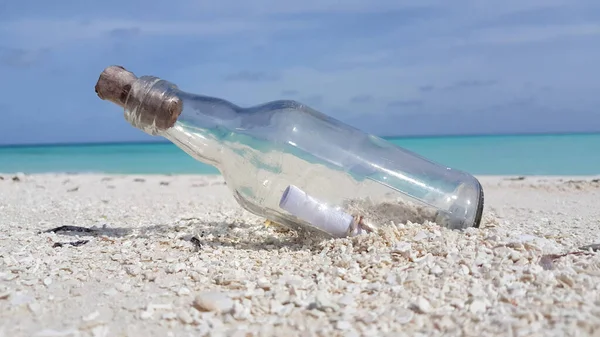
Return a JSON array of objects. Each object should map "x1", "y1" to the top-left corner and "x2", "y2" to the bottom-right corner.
[{"x1": 95, "y1": 66, "x2": 484, "y2": 237}]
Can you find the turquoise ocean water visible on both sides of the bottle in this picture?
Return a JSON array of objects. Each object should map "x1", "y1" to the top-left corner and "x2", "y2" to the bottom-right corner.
[{"x1": 0, "y1": 133, "x2": 600, "y2": 175}]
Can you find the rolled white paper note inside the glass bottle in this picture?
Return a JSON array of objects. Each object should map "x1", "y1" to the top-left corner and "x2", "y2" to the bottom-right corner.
[{"x1": 279, "y1": 185, "x2": 362, "y2": 237}]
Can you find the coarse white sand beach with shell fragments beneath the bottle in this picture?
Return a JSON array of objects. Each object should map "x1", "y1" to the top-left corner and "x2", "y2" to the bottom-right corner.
[{"x1": 0, "y1": 174, "x2": 600, "y2": 336}]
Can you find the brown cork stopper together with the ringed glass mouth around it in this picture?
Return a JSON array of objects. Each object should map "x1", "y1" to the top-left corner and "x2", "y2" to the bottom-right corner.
[{"x1": 95, "y1": 65, "x2": 183, "y2": 134}]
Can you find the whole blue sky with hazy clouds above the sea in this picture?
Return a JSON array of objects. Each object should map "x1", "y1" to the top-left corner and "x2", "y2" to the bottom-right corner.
[{"x1": 0, "y1": 0, "x2": 600, "y2": 144}]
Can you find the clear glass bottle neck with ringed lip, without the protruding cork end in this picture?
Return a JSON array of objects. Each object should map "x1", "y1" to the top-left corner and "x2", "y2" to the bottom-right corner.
[{"x1": 125, "y1": 76, "x2": 239, "y2": 168}]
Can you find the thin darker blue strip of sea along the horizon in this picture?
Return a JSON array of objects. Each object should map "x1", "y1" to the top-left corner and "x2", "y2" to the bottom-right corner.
[{"x1": 0, "y1": 131, "x2": 600, "y2": 148}]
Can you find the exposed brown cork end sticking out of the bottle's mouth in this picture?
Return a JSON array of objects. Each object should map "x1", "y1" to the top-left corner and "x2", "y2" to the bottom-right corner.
[{"x1": 95, "y1": 66, "x2": 137, "y2": 107}]
